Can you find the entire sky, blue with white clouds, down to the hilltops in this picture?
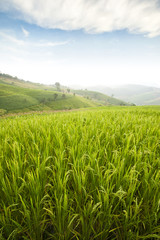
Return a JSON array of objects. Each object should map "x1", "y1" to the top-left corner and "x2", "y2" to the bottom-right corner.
[{"x1": 0, "y1": 0, "x2": 160, "y2": 87}]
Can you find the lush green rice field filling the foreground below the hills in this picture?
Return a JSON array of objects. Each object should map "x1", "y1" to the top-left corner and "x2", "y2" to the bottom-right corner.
[{"x1": 0, "y1": 106, "x2": 160, "y2": 240}]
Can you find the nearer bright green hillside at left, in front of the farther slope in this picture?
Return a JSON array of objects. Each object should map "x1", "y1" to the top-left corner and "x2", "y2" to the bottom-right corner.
[{"x1": 0, "y1": 74, "x2": 98, "y2": 115}]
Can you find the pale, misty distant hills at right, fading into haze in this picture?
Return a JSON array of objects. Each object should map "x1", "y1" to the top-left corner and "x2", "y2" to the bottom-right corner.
[{"x1": 88, "y1": 84, "x2": 160, "y2": 105}]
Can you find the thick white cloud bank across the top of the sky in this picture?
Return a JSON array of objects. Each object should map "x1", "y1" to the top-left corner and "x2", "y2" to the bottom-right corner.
[{"x1": 0, "y1": 0, "x2": 160, "y2": 37}]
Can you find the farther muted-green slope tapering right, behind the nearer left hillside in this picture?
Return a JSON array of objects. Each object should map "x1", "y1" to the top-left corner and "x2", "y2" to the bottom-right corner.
[{"x1": 72, "y1": 90, "x2": 132, "y2": 106}]
